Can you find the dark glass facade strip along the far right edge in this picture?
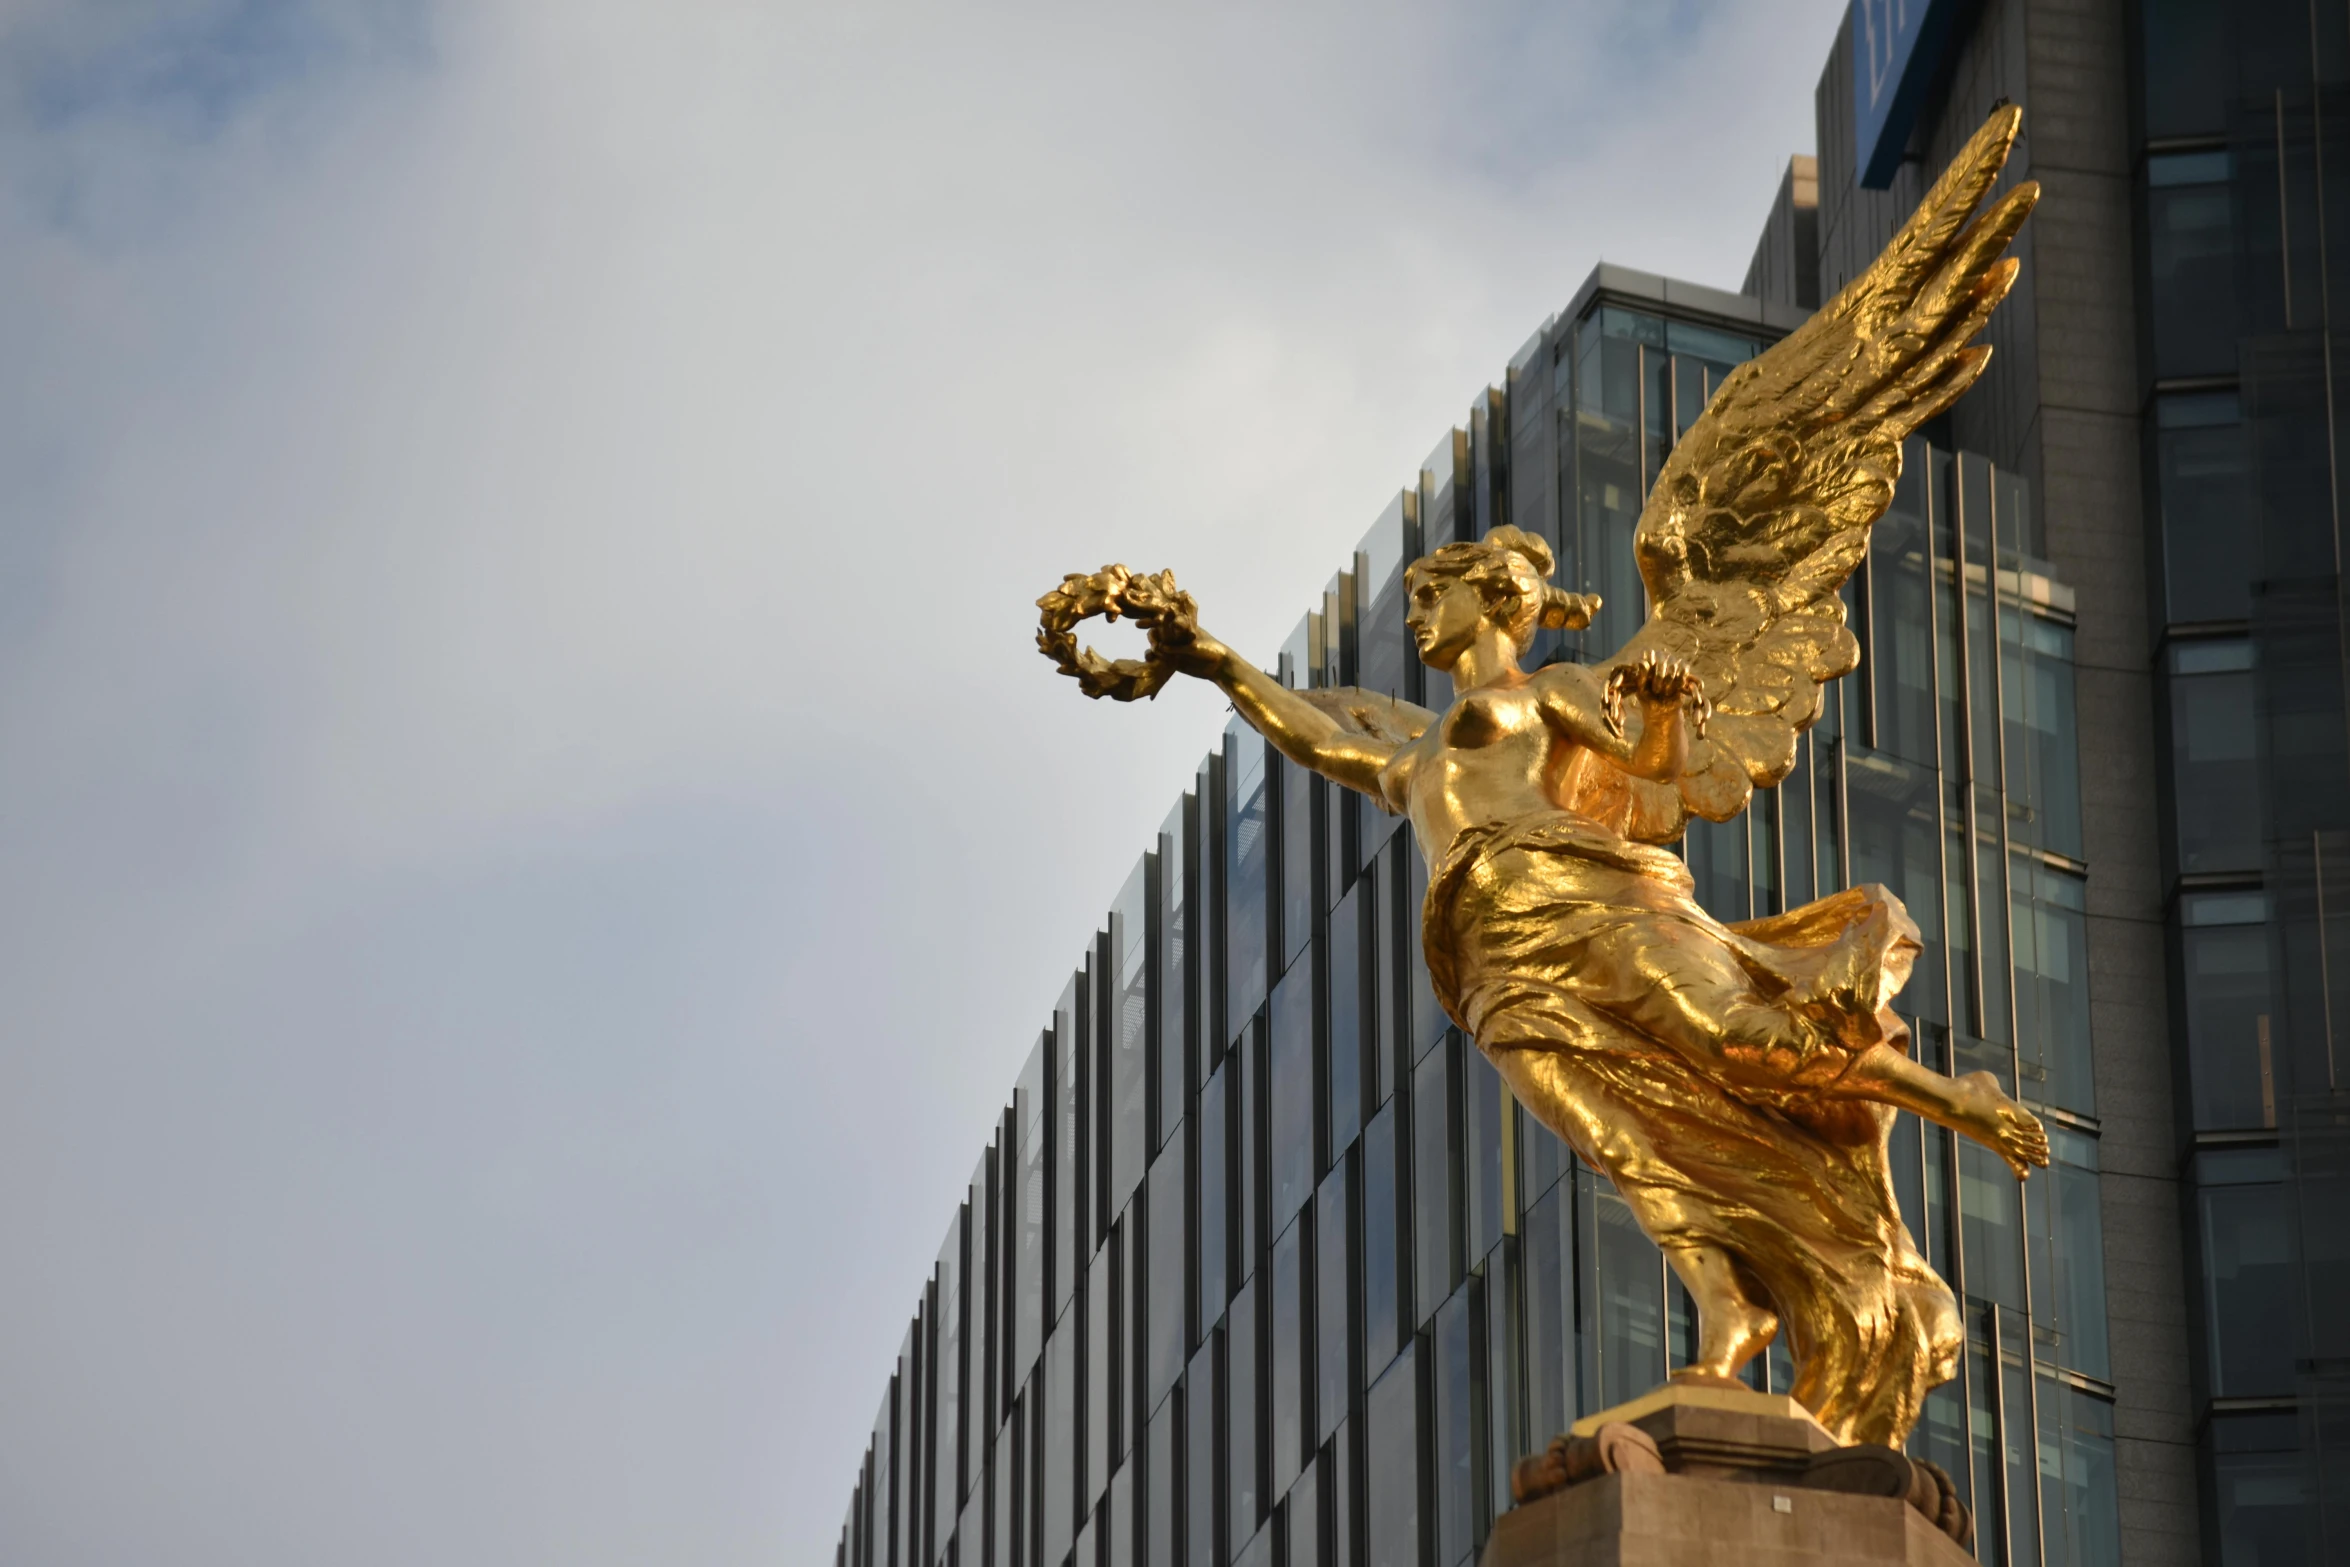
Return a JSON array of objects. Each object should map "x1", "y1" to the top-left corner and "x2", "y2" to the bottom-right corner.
[{"x1": 2131, "y1": 0, "x2": 2350, "y2": 1567}]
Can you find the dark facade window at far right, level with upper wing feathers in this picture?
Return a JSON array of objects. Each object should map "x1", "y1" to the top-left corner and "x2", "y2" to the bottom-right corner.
[{"x1": 2146, "y1": 150, "x2": 2235, "y2": 381}]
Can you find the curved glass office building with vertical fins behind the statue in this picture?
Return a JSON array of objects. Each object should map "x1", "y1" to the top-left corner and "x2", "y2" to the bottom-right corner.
[{"x1": 839, "y1": 268, "x2": 2120, "y2": 1567}]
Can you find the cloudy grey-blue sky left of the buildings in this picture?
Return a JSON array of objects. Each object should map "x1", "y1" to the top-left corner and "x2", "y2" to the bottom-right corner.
[{"x1": 0, "y1": 0, "x2": 1842, "y2": 1567}]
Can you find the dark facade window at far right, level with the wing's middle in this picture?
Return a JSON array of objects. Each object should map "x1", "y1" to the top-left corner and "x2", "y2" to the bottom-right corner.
[{"x1": 2155, "y1": 392, "x2": 2261, "y2": 625}]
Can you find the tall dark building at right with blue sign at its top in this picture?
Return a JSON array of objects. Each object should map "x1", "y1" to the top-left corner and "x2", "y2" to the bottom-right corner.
[{"x1": 1746, "y1": 0, "x2": 2350, "y2": 1567}]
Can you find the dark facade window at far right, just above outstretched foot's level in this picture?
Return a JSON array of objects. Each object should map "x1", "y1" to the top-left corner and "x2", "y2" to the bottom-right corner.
[{"x1": 2178, "y1": 893, "x2": 2284, "y2": 1130}]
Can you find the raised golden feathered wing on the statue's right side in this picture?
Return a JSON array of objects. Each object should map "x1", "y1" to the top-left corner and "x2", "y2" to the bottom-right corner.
[{"x1": 1612, "y1": 108, "x2": 2040, "y2": 836}]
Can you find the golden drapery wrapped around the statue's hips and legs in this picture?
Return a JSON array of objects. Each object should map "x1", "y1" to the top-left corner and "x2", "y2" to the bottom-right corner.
[{"x1": 1422, "y1": 811, "x2": 1962, "y2": 1445}]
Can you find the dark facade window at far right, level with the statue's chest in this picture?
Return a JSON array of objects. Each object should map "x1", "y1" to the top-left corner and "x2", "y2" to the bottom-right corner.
[{"x1": 2169, "y1": 641, "x2": 2263, "y2": 874}]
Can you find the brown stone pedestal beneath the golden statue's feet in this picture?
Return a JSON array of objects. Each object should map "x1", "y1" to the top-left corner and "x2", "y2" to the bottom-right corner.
[{"x1": 1481, "y1": 1384, "x2": 1974, "y2": 1567}]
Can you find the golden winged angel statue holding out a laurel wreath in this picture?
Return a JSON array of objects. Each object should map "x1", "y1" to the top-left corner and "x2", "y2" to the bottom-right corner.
[{"x1": 1039, "y1": 108, "x2": 2047, "y2": 1445}]
